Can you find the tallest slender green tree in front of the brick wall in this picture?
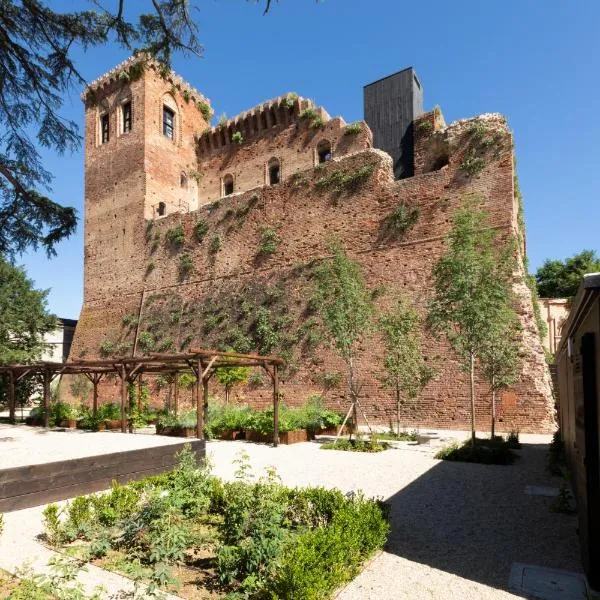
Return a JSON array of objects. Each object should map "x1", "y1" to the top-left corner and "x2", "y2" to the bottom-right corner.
[{"x1": 428, "y1": 196, "x2": 507, "y2": 443}]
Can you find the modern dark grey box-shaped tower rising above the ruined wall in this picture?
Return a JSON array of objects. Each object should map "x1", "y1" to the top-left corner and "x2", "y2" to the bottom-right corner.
[{"x1": 364, "y1": 67, "x2": 423, "y2": 179}]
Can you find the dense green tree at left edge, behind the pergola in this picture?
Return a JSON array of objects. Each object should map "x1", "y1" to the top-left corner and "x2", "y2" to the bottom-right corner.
[{"x1": 0, "y1": 256, "x2": 56, "y2": 364}]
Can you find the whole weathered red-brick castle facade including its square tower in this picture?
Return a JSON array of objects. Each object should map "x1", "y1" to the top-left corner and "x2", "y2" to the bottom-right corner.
[{"x1": 71, "y1": 55, "x2": 554, "y2": 432}]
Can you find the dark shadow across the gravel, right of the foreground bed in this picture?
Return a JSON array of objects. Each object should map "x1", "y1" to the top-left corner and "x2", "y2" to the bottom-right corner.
[{"x1": 386, "y1": 444, "x2": 582, "y2": 593}]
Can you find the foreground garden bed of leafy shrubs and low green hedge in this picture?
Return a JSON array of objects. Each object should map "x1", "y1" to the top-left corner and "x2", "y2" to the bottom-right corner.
[{"x1": 44, "y1": 451, "x2": 389, "y2": 600}]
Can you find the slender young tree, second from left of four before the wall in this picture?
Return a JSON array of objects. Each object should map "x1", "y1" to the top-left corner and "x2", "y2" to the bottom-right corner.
[{"x1": 379, "y1": 299, "x2": 433, "y2": 435}]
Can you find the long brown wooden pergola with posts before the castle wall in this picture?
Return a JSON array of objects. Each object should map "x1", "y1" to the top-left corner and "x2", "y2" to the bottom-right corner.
[{"x1": 0, "y1": 349, "x2": 283, "y2": 446}]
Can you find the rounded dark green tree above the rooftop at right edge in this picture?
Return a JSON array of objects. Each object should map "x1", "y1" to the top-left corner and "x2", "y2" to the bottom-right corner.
[{"x1": 535, "y1": 250, "x2": 600, "y2": 298}]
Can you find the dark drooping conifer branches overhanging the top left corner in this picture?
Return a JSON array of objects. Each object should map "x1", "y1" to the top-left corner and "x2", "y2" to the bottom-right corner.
[{"x1": 0, "y1": 0, "x2": 271, "y2": 256}]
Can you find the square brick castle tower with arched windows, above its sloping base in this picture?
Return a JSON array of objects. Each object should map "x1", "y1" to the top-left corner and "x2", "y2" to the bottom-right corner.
[{"x1": 83, "y1": 56, "x2": 212, "y2": 302}]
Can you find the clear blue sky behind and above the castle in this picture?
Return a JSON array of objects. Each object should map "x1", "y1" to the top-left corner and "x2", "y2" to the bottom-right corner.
[{"x1": 19, "y1": 0, "x2": 600, "y2": 318}]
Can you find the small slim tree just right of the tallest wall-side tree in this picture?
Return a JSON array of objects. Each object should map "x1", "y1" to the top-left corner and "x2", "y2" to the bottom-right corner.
[{"x1": 479, "y1": 304, "x2": 521, "y2": 438}]
